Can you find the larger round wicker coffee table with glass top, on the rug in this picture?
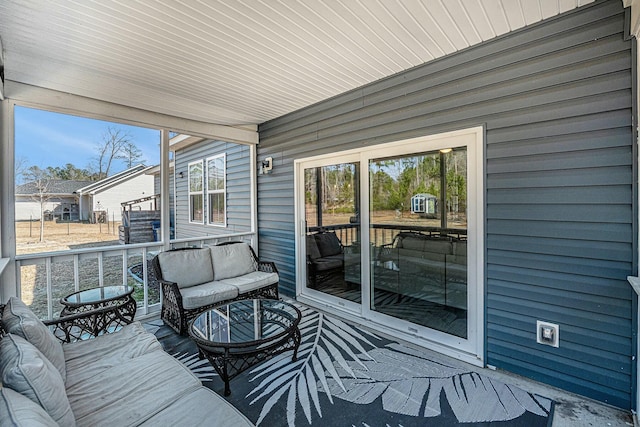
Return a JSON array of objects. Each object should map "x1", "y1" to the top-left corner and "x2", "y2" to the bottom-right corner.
[{"x1": 188, "y1": 299, "x2": 302, "y2": 396}]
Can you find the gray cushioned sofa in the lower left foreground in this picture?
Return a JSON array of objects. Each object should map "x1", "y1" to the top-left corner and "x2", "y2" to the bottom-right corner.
[{"x1": 0, "y1": 298, "x2": 253, "y2": 427}]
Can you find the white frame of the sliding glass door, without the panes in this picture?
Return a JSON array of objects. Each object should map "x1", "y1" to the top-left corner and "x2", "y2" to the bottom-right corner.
[{"x1": 294, "y1": 126, "x2": 485, "y2": 366}]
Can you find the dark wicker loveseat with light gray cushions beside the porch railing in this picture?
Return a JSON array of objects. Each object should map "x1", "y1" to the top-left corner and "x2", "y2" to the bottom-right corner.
[{"x1": 152, "y1": 242, "x2": 279, "y2": 335}]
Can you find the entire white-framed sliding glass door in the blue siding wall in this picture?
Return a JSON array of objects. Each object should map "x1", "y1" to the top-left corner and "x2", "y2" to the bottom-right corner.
[{"x1": 296, "y1": 128, "x2": 484, "y2": 363}]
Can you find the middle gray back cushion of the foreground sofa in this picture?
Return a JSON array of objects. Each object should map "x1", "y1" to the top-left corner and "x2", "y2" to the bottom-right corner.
[{"x1": 0, "y1": 334, "x2": 76, "y2": 427}]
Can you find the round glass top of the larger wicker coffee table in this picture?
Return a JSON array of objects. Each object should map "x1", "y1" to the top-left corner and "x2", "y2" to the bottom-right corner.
[{"x1": 190, "y1": 299, "x2": 300, "y2": 346}]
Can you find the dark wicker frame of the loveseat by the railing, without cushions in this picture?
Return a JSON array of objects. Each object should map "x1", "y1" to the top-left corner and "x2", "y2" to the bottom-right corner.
[{"x1": 152, "y1": 241, "x2": 279, "y2": 335}]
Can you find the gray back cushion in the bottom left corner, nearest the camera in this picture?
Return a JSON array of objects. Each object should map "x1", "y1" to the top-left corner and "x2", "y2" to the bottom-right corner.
[{"x1": 0, "y1": 387, "x2": 58, "y2": 427}]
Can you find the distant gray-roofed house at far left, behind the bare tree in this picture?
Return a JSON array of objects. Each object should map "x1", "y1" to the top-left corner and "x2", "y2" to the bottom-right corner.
[{"x1": 16, "y1": 179, "x2": 91, "y2": 221}]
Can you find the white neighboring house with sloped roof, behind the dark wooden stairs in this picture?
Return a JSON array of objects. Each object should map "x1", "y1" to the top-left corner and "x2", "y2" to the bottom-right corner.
[{"x1": 76, "y1": 165, "x2": 156, "y2": 222}]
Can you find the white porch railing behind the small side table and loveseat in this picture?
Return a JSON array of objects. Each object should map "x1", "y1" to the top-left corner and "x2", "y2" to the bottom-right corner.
[{"x1": 16, "y1": 232, "x2": 255, "y2": 319}]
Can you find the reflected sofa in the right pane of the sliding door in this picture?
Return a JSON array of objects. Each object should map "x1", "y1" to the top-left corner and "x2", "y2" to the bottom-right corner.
[{"x1": 374, "y1": 231, "x2": 467, "y2": 309}]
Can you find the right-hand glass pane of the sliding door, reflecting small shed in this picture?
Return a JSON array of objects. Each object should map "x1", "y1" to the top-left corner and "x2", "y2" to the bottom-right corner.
[{"x1": 369, "y1": 147, "x2": 468, "y2": 338}]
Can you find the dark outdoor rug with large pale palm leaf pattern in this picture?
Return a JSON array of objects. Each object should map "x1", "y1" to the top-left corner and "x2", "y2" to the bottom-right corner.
[{"x1": 147, "y1": 302, "x2": 554, "y2": 427}]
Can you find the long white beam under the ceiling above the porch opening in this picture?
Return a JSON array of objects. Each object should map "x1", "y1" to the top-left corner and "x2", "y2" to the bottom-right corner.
[{"x1": 5, "y1": 80, "x2": 259, "y2": 144}]
